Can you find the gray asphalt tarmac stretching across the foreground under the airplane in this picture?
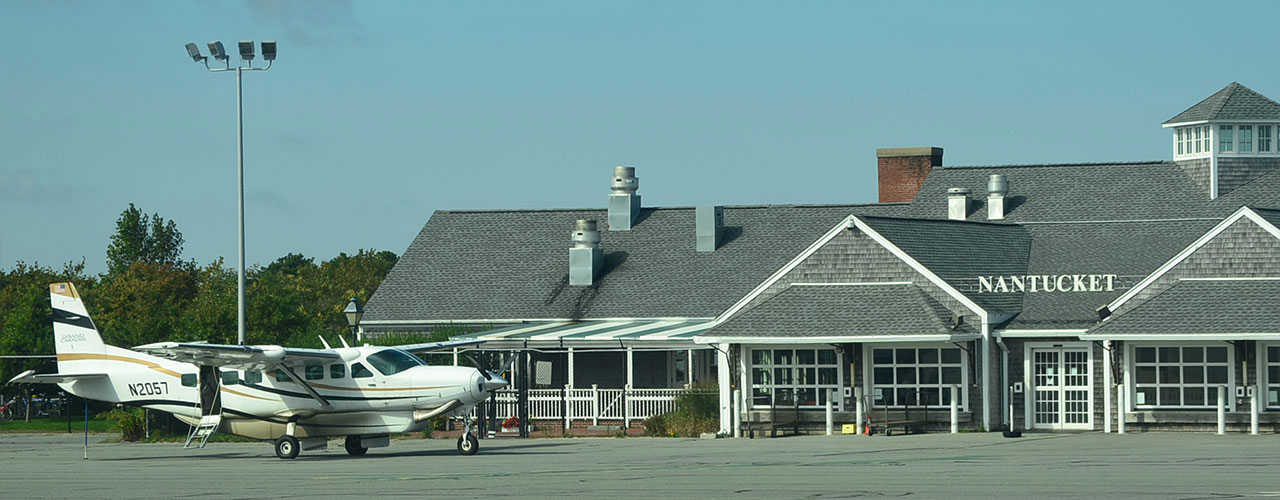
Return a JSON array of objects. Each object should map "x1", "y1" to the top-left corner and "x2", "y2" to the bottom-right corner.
[{"x1": 0, "y1": 432, "x2": 1280, "y2": 499}]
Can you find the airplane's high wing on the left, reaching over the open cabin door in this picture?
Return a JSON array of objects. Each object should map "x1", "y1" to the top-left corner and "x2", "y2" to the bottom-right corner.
[{"x1": 133, "y1": 341, "x2": 342, "y2": 370}]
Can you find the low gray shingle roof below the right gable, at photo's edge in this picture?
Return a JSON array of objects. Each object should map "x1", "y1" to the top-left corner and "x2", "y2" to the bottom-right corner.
[{"x1": 1089, "y1": 279, "x2": 1280, "y2": 338}]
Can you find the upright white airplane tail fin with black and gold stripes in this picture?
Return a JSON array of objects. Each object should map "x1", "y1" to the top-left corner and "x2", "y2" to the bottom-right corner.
[{"x1": 49, "y1": 283, "x2": 106, "y2": 373}]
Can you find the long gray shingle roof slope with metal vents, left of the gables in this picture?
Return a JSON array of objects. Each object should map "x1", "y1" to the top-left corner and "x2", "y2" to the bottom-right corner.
[{"x1": 365, "y1": 205, "x2": 905, "y2": 327}]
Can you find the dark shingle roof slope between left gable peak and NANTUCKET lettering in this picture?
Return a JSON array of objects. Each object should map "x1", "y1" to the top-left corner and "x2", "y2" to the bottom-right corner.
[{"x1": 859, "y1": 216, "x2": 1032, "y2": 313}]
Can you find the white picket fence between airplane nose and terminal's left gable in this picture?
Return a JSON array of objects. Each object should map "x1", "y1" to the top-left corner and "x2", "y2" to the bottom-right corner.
[{"x1": 476, "y1": 385, "x2": 686, "y2": 428}]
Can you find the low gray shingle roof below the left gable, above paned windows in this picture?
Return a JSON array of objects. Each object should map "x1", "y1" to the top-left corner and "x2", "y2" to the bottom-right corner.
[{"x1": 703, "y1": 284, "x2": 973, "y2": 339}]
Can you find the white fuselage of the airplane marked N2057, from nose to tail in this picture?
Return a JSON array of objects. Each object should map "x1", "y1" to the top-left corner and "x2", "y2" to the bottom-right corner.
[{"x1": 59, "y1": 347, "x2": 488, "y2": 440}]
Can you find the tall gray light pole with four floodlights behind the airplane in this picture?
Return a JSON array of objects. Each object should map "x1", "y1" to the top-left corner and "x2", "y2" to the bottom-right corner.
[{"x1": 187, "y1": 40, "x2": 275, "y2": 345}]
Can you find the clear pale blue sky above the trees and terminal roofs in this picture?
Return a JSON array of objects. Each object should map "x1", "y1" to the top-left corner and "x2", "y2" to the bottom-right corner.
[{"x1": 0, "y1": 0, "x2": 1280, "y2": 272}]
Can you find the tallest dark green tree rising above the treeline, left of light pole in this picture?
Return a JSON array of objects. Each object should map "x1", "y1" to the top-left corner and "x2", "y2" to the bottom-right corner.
[{"x1": 106, "y1": 203, "x2": 183, "y2": 276}]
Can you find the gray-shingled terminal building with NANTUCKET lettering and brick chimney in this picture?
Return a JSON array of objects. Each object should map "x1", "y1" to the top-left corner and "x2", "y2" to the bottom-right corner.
[{"x1": 362, "y1": 83, "x2": 1280, "y2": 432}]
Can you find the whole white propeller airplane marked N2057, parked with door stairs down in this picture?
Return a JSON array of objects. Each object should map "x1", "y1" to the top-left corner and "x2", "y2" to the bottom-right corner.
[{"x1": 9, "y1": 283, "x2": 507, "y2": 459}]
